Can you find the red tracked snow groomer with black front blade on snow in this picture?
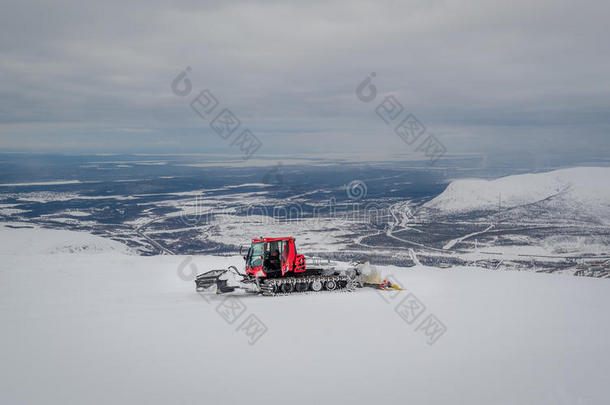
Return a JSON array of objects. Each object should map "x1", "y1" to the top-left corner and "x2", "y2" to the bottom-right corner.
[{"x1": 195, "y1": 236, "x2": 363, "y2": 295}]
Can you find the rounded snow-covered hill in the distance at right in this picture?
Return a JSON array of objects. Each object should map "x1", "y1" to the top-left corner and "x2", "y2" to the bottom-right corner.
[{"x1": 425, "y1": 167, "x2": 610, "y2": 219}]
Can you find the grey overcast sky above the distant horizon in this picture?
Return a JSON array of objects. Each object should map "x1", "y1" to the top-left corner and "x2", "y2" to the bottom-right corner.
[{"x1": 0, "y1": 0, "x2": 610, "y2": 161}]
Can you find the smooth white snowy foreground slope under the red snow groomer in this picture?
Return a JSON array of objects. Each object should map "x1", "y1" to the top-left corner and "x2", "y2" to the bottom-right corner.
[{"x1": 0, "y1": 227, "x2": 610, "y2": 405}]
